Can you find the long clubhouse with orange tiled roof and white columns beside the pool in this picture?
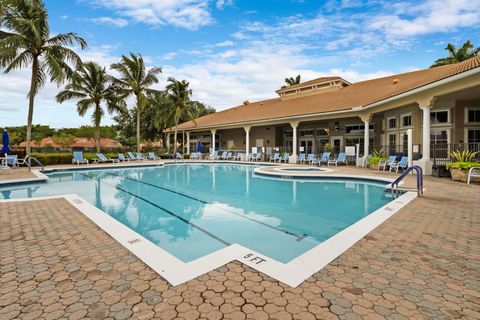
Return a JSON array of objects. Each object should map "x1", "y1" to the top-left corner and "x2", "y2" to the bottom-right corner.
[{"x1": 171, "y1": 57, "x2": 480, "y2": 173}]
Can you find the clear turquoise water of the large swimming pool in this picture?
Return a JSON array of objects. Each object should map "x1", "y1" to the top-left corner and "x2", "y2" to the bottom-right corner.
[{"x1": 0, "y1": 164, "x2": 391, "y2": 263}]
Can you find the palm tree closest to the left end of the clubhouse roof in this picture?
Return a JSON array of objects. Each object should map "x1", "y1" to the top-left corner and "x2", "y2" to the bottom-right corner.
[{"x1": 165, "y1": 77, "x2": 197, "y2": 153}]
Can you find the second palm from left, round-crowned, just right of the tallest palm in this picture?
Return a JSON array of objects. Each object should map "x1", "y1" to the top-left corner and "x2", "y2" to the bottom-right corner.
[{"x1": 56, "y1": 62, "x2": 124, "y2": 152}]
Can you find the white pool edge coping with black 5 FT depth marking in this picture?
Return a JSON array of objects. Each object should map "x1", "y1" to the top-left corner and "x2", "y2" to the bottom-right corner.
[{"x1": 0, "y1": 161, "x2": 417, "y2": 287}]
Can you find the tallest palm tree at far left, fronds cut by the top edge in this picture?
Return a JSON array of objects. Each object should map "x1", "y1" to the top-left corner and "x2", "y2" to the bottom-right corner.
[{"x1": 0, "y1": 0, "x2": 87, "y2": 155}]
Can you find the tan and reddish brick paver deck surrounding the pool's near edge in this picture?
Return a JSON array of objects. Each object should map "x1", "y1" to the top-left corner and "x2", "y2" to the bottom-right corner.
[{"x1": 0, "y1": 169, "x2": 480, "y2": 320}]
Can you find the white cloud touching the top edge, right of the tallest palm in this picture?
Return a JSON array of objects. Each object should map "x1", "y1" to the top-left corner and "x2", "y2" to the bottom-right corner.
[{"x1": 86, "y1": 0, "x2": 213, "y2": 30}]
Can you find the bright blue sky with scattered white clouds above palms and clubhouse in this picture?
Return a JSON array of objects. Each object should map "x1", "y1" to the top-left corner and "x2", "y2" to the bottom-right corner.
[{"x1": 0, "y1": 0, "x2": 480, "y2": 128}]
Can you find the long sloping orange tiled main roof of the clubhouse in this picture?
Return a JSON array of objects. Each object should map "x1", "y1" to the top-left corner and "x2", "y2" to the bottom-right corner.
[{"x1": 178, "y1": 57, "x2": 480, "y2": 130}]
